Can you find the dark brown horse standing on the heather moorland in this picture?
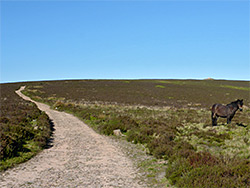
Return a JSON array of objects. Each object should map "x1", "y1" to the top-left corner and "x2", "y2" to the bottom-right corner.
[{"x1": 211, "y1": 99, "x2": 243, "y2": 126}]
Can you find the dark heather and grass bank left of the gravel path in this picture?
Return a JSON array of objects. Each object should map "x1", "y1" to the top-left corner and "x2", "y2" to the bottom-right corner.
[{"x1": 0, "y1": 84, "x2": 51, "y2": 171}]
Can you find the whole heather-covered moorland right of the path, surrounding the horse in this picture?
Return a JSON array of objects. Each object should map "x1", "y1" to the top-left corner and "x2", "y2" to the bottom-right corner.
[{"x1": 3, "y1": 80, "x2": 250, "y2": 187}]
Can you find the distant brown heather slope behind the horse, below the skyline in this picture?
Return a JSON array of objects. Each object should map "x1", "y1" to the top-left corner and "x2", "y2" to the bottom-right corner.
[{"x1": 22, "y1": 80, "x2": 250, "y2": 108}]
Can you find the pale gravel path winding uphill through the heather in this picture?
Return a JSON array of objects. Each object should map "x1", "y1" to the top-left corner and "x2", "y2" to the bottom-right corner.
[{"x1": 0, "y1": 87, "x2": 146, "y2": 188}]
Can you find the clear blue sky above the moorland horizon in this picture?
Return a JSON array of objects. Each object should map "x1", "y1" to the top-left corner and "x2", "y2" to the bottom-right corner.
[{"x1": 0, "y1": 0, "x2": 250, "y2": 83}]
